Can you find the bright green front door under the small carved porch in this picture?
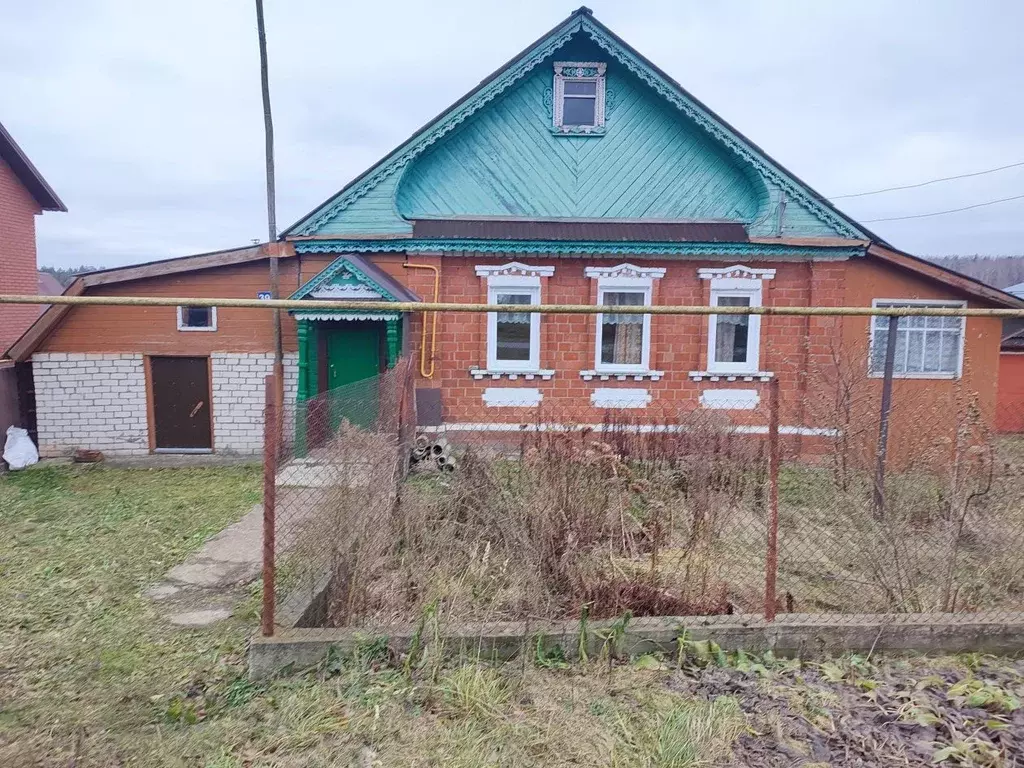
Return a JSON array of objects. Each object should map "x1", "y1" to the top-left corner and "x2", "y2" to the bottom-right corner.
[{"x1": 318, "y1": 321, "x2": 384, "y2": 431}]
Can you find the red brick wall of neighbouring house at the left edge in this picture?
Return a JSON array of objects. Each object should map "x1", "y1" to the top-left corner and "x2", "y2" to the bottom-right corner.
[{"x1": 0, "y1": 155, "x2": 42, "y2": 355}]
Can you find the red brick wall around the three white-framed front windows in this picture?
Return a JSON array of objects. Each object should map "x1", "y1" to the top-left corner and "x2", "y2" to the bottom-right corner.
[{"x1": 414, "y1": 255, "x2": 842, "y2": 423}]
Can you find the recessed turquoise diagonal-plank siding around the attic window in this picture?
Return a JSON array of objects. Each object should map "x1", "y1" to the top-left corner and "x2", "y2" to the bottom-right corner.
[{"x1": 397, "y1": 44, "x2": 768, "y2": 221}]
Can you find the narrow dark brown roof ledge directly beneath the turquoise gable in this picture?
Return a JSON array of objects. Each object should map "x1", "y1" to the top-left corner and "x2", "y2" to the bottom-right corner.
[{"x1": 413, "y1": 218, "x2": 748, "y2": 243}]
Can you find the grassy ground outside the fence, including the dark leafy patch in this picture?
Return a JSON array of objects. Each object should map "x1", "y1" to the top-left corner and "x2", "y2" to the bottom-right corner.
[{"x1": 0, "y1": 460, "x2": 1024, "y2": 768}]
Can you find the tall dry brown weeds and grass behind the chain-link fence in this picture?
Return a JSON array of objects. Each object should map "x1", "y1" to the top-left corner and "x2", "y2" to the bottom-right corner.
[{"x1": 312, "y1": 407, "x2": 1024, "y2": 631}]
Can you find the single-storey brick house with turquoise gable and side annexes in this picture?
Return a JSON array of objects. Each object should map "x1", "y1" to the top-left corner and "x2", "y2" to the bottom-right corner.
[{"x1": 8, "y1": 8, "x2": 1024, "y2": 462}]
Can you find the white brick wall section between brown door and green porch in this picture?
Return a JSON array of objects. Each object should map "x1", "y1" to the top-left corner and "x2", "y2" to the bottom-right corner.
[{"x1": 210, "y1": 352, "x2": 299, "y2": 454}]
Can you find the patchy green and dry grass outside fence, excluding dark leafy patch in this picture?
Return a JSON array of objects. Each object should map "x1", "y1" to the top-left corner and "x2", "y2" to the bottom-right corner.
[{"x1": 0, "y1": 460, "x2": 745, "y2": 768}]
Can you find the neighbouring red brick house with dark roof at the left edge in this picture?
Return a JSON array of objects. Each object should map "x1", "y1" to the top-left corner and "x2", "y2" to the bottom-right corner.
[{"x1": 0, "y1": 124, "x2": 68, "y2": 442}]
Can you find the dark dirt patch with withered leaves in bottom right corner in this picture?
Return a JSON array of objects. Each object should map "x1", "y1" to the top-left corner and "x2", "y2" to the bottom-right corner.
[{"x1": 667, "y1": 656, "x2": 1024, "y2": 768}]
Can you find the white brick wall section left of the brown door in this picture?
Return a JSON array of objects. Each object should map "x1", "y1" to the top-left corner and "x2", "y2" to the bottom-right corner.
[{"x1": 32, "y1": 352, "x2": 150, "y2": 457}]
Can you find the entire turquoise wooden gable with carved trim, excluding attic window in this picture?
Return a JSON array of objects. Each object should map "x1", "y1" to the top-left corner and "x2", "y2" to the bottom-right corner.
[{"x1": 287, "y1": 9, "x2": 867, "y2": 239}]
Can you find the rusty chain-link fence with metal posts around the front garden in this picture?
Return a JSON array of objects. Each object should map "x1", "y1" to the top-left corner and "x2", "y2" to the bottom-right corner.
[{"x1": 260, "y1": 324, "x2": 1024, "y2": 638}]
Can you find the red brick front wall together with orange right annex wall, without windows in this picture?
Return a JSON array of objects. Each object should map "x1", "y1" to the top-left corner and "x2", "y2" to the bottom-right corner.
[{"x1": 382, "y1": 254, "x2": 999, "y2": 468}]
